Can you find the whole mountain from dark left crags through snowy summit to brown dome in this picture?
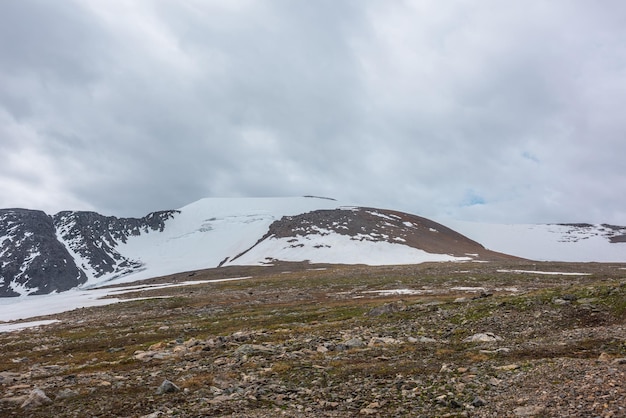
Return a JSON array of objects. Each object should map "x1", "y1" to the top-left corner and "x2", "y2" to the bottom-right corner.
[{"x1": 0, "y1": 197, "x2": 505, "y2": 297}]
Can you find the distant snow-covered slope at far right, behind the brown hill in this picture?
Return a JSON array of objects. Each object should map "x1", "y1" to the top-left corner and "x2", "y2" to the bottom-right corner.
[{"x1": 443, "y1": 221, "x2": 626, "y2": 263}]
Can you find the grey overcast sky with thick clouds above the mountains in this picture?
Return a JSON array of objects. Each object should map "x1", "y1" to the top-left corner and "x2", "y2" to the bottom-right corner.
[{"x1": 0, "y1": 0, "x2": 626, "y2": 225}]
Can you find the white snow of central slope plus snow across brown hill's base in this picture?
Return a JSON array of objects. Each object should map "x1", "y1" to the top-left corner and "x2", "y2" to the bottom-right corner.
[{"x1": 82, "y1": 197, "x2": 471, "y2": 288}]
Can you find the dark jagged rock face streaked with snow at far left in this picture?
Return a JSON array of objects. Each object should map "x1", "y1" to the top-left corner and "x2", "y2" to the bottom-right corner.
[{"x1": 0, "y1": 209, "x2": 176, "y2": 297}]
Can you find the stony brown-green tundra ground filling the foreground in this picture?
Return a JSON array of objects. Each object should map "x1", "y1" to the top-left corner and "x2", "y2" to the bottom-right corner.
[{"x1": 0, "y1": 261, "x2": 626, "y2": 417}]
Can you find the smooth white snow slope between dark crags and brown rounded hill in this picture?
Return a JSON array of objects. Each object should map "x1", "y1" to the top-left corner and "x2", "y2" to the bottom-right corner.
[{"x1": 87, "y1": 197, "x2": 339, "y2": 286}]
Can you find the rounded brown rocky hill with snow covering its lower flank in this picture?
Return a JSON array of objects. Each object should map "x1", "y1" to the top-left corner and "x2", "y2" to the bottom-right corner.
[{"x1": 228, "y1": 207, "x2": 512, "y2": 265}]
